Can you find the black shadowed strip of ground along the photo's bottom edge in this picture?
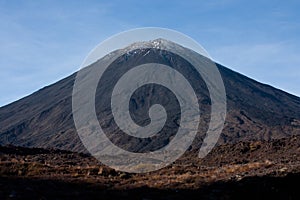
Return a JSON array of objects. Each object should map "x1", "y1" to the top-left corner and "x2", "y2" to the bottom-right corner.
[{"x1": 0, "y1": 173, "x2": 300, "y2": 199}]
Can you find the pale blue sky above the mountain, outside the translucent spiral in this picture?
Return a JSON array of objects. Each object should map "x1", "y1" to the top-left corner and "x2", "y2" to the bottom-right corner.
[{"x1": 0, "y1": 0, "x2": 300, "y2": 106}]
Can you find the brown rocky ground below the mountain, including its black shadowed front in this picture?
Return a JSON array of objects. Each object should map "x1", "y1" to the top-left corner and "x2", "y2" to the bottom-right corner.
[{"x1": 0, "y1": 136, "x2": 300, "y2": 199}]
